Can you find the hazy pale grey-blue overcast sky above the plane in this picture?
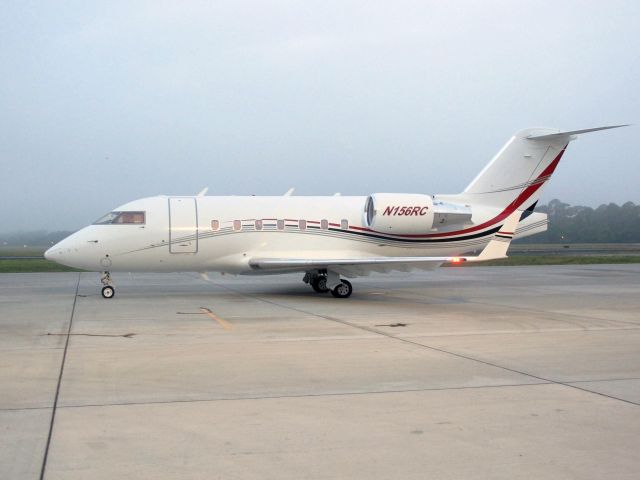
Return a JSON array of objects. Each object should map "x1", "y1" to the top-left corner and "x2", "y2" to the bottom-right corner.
[{"x1": 0, "y1": 0, "x2": 640, "y2": 232}]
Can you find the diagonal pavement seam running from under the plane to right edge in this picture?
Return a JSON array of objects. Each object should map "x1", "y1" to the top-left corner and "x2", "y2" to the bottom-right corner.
[{"x1": 212, "y1": 282, "x2": 640, "y2": 406}]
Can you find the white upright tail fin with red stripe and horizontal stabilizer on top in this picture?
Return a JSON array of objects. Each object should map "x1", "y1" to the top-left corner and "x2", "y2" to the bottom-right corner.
[{"x1": 460, "y1": 125, "x2": 625, "y2": 210}]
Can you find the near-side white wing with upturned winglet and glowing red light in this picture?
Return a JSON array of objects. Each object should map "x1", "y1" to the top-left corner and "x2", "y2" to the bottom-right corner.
[{"x1": 249, "y1": 210, "x2": 522, "y2": 277}]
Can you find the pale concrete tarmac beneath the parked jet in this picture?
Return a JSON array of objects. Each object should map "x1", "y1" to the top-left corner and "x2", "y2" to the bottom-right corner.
[{"x1": 0, "y1": 265, "x2": 640, "y2": 480}]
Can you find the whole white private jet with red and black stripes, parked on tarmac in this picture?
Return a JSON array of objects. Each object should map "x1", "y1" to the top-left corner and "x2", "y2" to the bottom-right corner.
[{"x1": 45, "y1": 125, "x2": 624, "y2": 298}]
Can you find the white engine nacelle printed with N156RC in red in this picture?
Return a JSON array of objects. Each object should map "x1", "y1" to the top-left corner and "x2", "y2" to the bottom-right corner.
[{"x1": 365, "y1": 193, "x2": 471, "y2": 235}]
